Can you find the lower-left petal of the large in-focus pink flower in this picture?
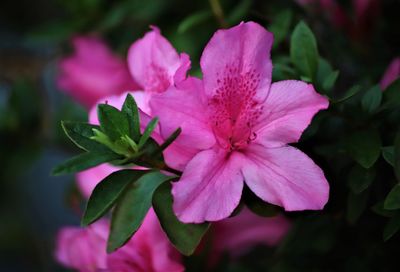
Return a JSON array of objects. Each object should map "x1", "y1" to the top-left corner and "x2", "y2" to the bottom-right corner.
[{"x1": 172, "y1": 150, "x2": 243, "y2": 223}]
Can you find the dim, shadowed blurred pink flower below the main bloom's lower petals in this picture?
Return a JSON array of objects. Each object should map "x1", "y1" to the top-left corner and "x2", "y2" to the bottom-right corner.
[{"x1": 211, "y1": 208, "x2": 290, "y2": 257}]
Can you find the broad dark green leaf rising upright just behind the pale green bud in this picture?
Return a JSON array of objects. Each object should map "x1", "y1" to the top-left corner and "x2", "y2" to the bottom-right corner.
[{"x1": 97, "y1": 104, "x2": 130, "y2": 141}]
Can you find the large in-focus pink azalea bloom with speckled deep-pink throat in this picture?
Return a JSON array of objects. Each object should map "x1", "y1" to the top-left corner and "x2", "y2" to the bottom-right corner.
[{"x1": 150, "y1": 22, "x2": 329, "y2": 222}]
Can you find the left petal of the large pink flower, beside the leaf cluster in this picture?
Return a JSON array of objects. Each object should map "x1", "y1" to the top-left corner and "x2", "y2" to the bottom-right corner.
[{"x1": 150, "y1": 78, "x2": 215, "y2": 169}]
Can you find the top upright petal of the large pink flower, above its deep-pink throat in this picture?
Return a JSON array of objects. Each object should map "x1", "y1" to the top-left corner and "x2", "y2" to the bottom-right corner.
[{"x1": 200, "y1": 22, "x2": 273, "y2": 101}]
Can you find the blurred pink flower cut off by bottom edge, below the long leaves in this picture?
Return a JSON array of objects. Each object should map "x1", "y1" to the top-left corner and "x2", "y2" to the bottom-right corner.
[{"x1": 55, "y1": 210, "x2": 184, "y2": 272}]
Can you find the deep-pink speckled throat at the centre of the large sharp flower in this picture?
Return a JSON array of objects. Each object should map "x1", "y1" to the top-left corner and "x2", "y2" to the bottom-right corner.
[{"x1": 208, "y1": 65, "x2": 263, "y2": 150}]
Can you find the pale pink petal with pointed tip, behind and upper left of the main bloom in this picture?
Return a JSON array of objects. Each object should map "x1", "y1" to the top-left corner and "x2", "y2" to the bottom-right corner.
[{"x1": 128, "y1": 27, "x2": 190, "y2": 93}]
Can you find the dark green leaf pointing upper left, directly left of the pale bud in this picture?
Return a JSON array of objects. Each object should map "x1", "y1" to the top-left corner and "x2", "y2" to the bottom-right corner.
[{"x1": 61, "y1": 121, "x2": 105, "y2": 151}]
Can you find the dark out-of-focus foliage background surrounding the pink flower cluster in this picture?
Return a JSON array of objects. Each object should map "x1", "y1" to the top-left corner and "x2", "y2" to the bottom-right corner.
[{"x1": 0, "y1": 0, "x2": 400, "y2": 272}]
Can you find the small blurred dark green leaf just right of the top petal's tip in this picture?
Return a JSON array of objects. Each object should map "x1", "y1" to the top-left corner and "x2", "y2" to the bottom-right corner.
[{"x1": 268, "y1": 9, "x2": 293, "y2": 47}]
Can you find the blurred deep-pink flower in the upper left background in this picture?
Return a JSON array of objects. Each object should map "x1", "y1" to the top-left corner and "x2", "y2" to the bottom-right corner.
[{"x1": 57, "y1": 36, "x2": 138, "y2": 108}]
